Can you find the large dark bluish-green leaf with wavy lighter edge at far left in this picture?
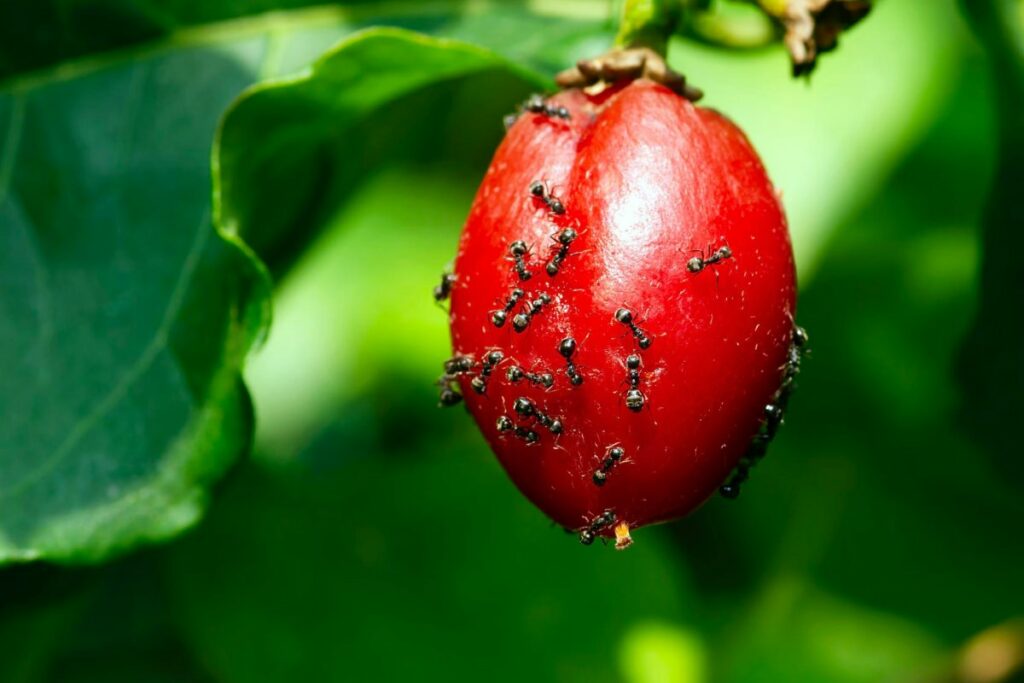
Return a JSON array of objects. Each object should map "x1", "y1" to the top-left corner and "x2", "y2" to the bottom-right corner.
[{"x1": 0, "y1": 38, "x2": 267, "y2": 562}]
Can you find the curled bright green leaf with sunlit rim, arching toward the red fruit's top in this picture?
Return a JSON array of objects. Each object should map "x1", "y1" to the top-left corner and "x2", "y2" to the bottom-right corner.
[{"x1": 214, "y1": 29, "x2": 545, "y2": 274}]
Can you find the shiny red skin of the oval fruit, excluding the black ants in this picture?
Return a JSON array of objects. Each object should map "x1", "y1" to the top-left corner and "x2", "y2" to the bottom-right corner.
[{"x1": 451, "y1": 81, "x2": 796, "y2": 536}]
